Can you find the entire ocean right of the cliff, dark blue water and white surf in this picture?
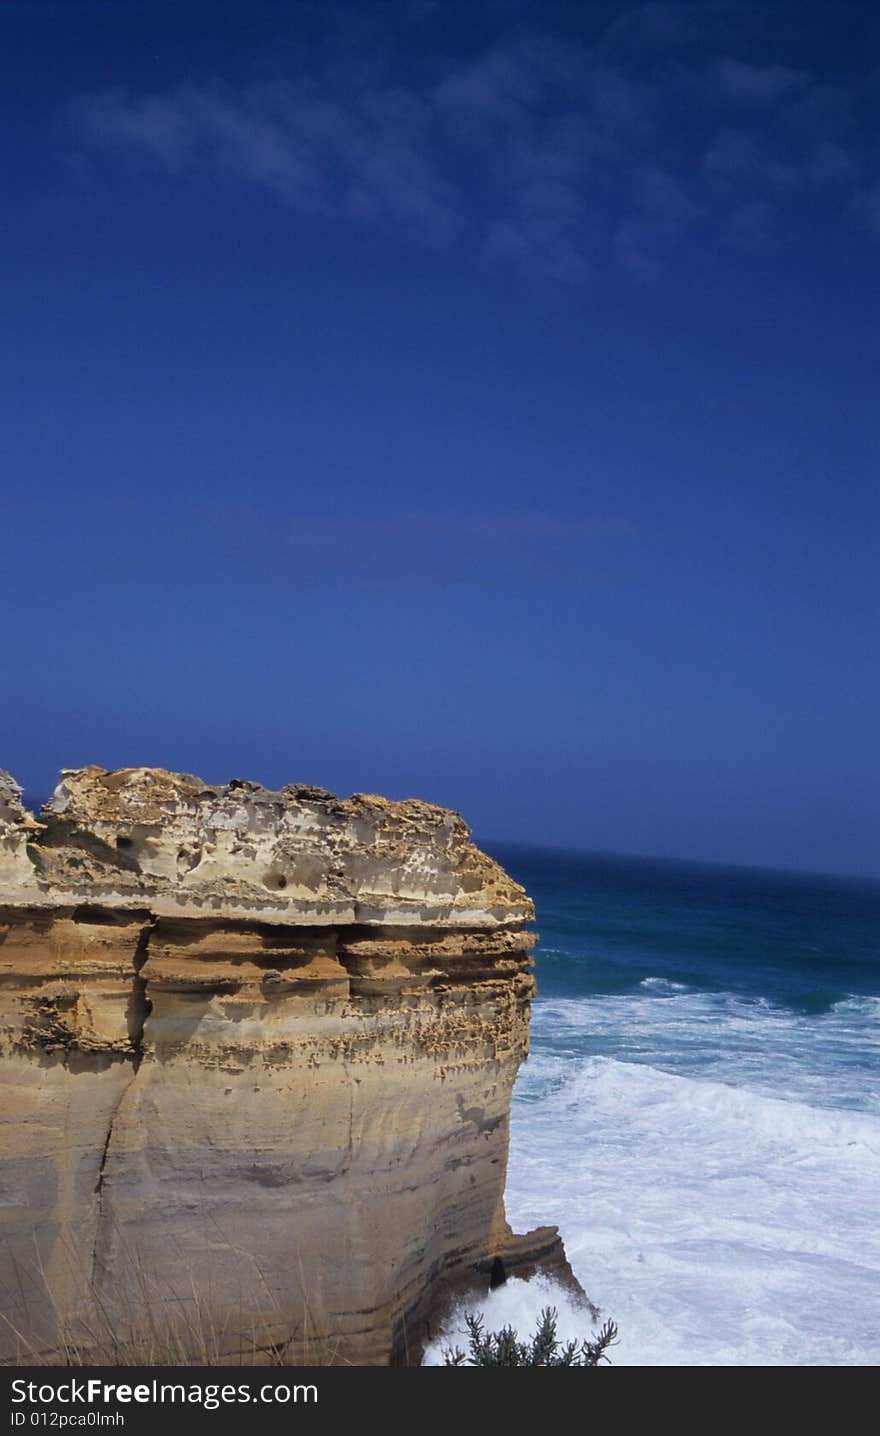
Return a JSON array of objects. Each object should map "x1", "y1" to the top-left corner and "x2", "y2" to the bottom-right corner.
[{"x1": 426, "y1": 844, "x2": 880, "y2": 1366}]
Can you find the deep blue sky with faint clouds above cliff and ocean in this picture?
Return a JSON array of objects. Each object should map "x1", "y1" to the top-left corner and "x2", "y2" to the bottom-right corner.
[{"x1": 0, "y1": 0, "x2": 880, "y2": 877}]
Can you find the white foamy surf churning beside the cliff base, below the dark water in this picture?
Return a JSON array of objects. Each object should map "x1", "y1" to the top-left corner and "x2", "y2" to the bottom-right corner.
[{"x1": 429, "y1": 989, "x2": 880, "y2": 1366}]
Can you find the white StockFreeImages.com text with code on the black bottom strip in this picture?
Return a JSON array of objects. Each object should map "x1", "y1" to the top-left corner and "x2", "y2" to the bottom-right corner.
[{"x1": 11, "y1": 1377, "x2": 317, "y2": 1426}]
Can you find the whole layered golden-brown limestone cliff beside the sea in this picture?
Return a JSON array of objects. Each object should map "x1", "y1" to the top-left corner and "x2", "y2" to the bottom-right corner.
[{"x1": 0, "y1": 767, "x2": 574, "y2": 1363}]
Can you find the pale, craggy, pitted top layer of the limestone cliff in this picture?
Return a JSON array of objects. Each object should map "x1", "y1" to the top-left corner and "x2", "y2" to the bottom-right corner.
[{"x1": 0, "y1": 765, "x2": 534, "y2": 928}]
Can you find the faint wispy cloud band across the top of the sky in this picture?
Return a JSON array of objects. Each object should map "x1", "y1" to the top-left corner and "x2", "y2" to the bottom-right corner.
[{"x1": 72, "y1": 3, "x2": 880, "y2": 281}]
